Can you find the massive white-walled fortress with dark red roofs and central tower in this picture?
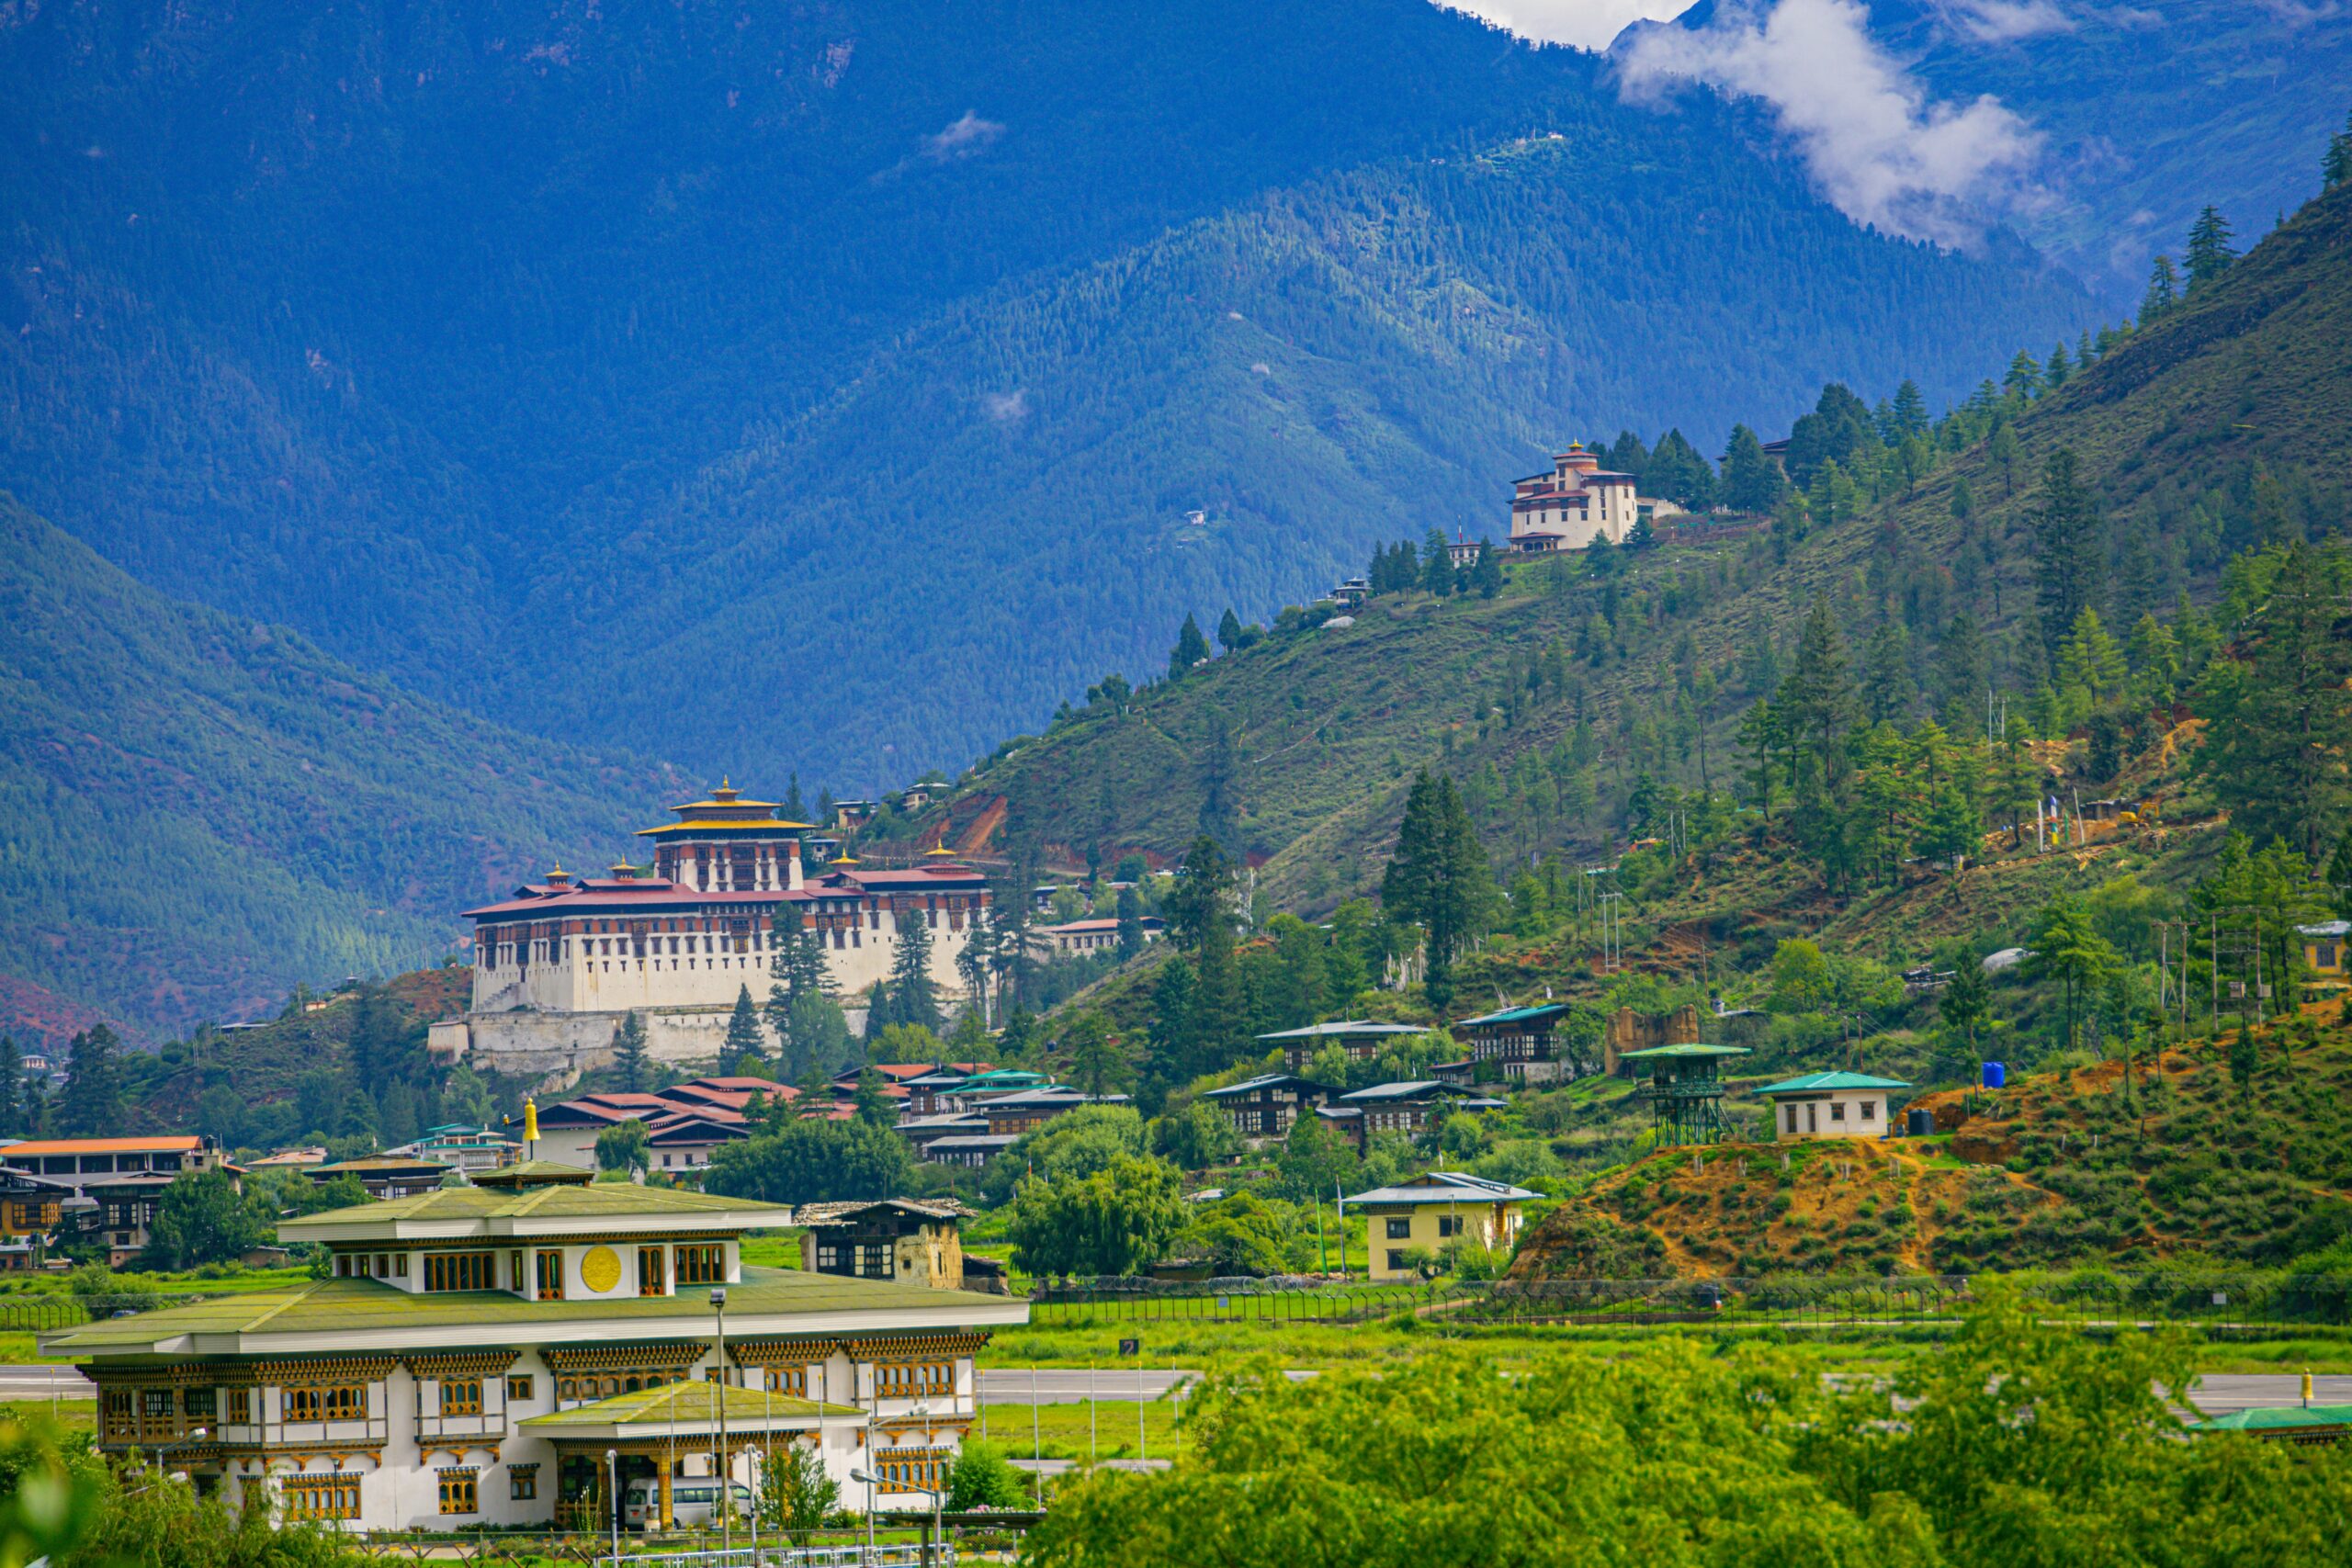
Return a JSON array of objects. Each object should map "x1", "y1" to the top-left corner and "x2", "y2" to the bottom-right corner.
[{"x1": 448, "y1": 785, "x2": 988, "y2": 1075}]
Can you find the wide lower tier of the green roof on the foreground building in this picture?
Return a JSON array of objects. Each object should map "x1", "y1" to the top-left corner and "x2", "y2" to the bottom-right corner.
[{"x1": 42, "y1": 1259, "x2": 1009, "y2": 1354}]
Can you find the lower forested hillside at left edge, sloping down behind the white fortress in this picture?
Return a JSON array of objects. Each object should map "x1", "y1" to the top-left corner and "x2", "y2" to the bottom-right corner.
[{"x1": 0, "y1": 496, "x2": 680, "y2": 1042}]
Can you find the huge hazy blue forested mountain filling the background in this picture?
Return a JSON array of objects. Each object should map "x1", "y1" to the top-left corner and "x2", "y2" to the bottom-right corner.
[{"x1": 0, "y1": 0, "x2": 2096, "y2": 790}]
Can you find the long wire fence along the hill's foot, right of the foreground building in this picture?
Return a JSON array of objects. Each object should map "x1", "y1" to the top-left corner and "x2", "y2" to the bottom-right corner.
[{"x1": 1030, "y1": 1269, "x2": 2352, "y2": 1333}]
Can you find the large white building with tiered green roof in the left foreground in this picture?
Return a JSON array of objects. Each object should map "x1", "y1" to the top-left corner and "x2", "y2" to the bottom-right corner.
[{"x1": 42, "y1": 1161, "x2": 1028, "y2": 1530}]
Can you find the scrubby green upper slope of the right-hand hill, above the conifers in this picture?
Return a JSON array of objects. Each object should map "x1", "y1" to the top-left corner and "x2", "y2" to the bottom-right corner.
[{"x1": 935, "y1": 175, "x2": 2352, "y2": 908}]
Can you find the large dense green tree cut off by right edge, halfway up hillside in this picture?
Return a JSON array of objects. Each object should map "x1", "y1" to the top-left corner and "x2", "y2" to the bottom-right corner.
[{"x1": 2192, "y1": 541, "x2": 2352, "y2": 865}]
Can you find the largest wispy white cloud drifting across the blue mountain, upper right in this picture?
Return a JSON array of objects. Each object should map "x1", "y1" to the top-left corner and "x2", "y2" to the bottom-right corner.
[{"x1": 1618, "y1": 0, "x2": 2041, "y2": 247}]
